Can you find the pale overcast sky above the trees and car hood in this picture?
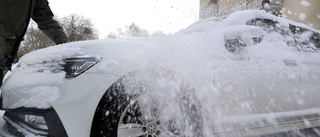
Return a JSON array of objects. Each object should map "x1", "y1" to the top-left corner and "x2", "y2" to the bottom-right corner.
[{"x1": 48, "y1": 0, "x2": 200, "y2": 38}]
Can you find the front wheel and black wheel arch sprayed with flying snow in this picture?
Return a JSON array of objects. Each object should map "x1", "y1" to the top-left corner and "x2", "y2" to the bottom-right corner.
[{"x1": 91, "y1": 69, "x2": 202, "y2": 137}]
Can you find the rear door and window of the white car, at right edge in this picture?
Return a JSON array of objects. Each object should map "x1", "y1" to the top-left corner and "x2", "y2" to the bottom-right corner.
[{"x1": 290, "y1": 25, "x2": 320, "y2": 110}]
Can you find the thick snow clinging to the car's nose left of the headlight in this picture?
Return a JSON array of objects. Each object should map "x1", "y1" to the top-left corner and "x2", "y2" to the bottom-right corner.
[{"x1": 3, "y1": 45, "x2": 81, "y2": 108}]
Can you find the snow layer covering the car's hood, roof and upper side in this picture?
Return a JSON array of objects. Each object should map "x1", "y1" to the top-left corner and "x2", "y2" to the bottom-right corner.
[{"x1": 3, "y1": 11, "x2": 320, "y2": 113}]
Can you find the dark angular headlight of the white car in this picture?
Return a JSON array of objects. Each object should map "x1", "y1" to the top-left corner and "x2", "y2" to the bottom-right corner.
[{"x1": 63, "y1": 55, "x2": 99, "y2": 78}]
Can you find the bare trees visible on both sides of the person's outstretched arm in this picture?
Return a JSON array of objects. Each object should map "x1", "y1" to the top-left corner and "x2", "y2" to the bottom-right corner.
[{"x1": 18, "y1": 14, "x2": 98, "y2": 57}]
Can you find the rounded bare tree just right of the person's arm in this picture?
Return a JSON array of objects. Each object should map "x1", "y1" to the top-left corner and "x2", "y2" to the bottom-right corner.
[{"x1": 61, "y1": 14, "x2": 98, "y2": 41}]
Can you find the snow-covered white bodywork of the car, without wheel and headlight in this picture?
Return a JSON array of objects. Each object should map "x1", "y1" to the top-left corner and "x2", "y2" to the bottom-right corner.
[{"x1": 2, "y1": 11, "x2": 320, "y2": 137}]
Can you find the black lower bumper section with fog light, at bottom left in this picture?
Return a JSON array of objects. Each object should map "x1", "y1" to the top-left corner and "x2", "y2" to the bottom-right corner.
[{"x1": 3, "y1": 108, "x2": 68, "y2": 137}]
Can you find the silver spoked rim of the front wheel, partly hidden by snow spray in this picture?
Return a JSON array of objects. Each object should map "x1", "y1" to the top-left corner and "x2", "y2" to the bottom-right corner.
[{"x1": 117, "y1": 94, "x2": 184, "y2": 137}]
